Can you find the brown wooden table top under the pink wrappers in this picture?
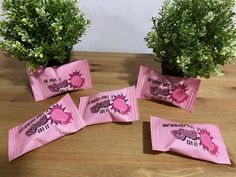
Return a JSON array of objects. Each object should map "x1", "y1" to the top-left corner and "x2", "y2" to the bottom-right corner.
[{"x1": 0, "y1": 52, "x2": 236, "y2": 177}]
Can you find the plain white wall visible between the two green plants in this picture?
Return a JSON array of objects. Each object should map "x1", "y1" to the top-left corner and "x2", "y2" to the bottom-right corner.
[{"x1": 74, "y1": 0, "x2": 163, "y2": 53}]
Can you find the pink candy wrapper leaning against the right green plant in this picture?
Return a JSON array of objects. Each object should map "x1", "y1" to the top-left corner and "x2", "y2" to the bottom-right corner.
[{"x1": 136, "y1": 66, "x2": 201, "y2": 112}]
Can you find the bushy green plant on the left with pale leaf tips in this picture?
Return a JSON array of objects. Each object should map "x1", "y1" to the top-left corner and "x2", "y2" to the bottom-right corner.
[{"x1": 0, "y1": 0, "x2": 90, "y2": 69}]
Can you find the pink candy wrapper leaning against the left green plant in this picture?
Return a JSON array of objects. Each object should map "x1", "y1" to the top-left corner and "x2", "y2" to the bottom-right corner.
[{"x1": 28, "y1": 60, "x2": 92, "y2": 101}]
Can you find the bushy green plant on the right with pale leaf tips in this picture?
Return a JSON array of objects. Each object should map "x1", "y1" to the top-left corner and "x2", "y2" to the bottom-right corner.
[{"x1": 145, "y1": 0, "x2": 236, "y2": 78}]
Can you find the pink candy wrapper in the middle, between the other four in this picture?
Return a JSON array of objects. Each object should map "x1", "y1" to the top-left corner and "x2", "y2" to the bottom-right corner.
[{"x1": 79, "y1": 86, "x2": 139, "y2": 125}]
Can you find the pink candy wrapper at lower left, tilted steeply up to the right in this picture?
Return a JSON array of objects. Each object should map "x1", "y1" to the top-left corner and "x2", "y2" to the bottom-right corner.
[{"x1": 8, "y1": 94, "x2": 85, "y2": 161}]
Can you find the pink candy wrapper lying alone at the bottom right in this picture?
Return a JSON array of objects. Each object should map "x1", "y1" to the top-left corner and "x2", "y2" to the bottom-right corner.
[{"x1": 150, "y1": 117, "x2": 231, "y2": 164}]
